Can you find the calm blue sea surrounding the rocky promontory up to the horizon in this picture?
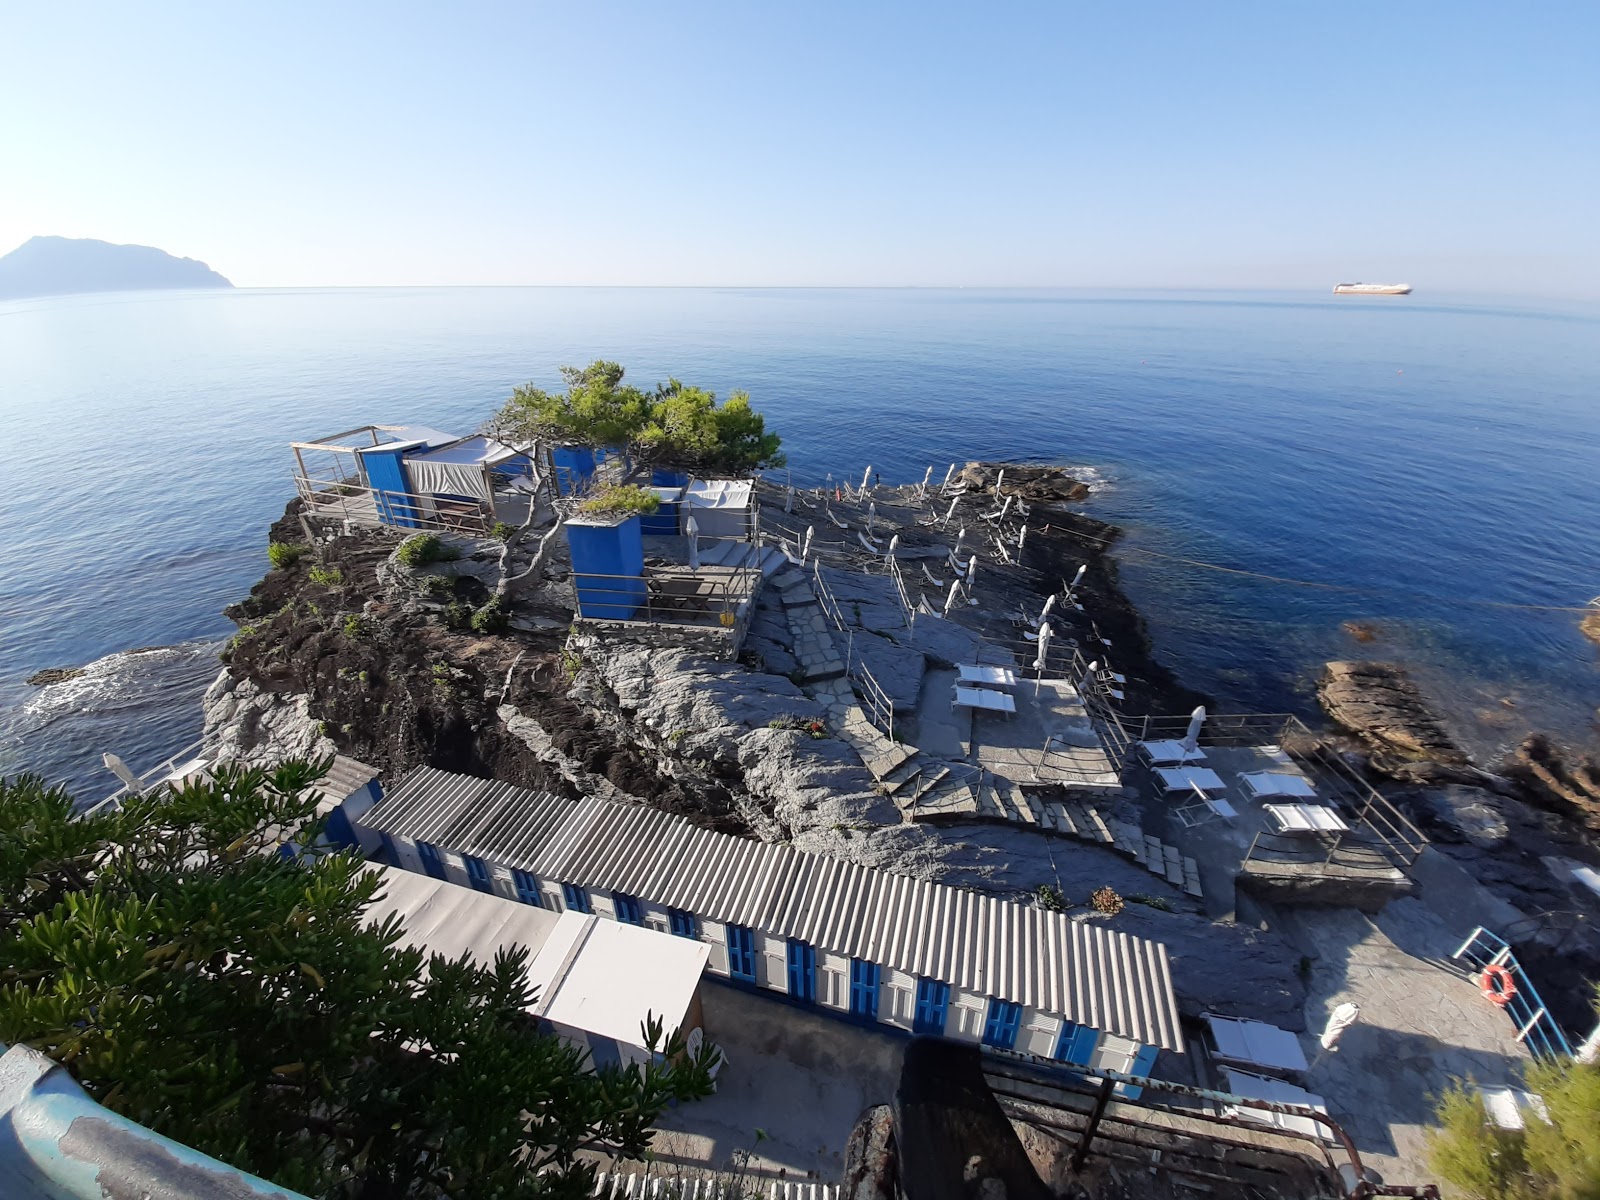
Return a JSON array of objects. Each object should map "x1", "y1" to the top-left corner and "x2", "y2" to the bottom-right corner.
[{"x1": 0, "y1": 288, "x2": 1600, "y2": 795}]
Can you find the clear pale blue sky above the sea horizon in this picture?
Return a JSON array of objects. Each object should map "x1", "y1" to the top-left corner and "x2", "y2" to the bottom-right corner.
[{"x1": 0, "y1": 0, "x2": 1600, "y2": 296}]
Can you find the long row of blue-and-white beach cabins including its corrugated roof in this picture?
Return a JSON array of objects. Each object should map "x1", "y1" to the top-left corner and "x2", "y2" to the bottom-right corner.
[{"x1": 358, "y1": 768, "x2": 1182, "y2": 1075}]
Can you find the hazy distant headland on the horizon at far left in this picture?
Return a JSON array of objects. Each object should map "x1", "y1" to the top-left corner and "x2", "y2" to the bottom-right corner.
[{"x1": 0, "y1": 237, "x2": 234, "y2": 299}]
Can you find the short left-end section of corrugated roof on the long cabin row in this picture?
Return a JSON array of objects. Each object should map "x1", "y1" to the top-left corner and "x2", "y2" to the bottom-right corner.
[{"x1": 362, "y1": 766, "x2": 576, "y2": 866}]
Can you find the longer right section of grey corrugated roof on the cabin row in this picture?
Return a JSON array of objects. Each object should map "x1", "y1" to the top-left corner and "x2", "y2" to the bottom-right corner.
[{"x1": 521, "y1": 809, "x2": 1182, "y2": 1050}]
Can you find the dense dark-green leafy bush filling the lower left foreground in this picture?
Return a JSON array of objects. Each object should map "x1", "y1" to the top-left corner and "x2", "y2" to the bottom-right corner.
[{"x1": 0, "y1": 762, "x2": 710, "y2": 1200}]
